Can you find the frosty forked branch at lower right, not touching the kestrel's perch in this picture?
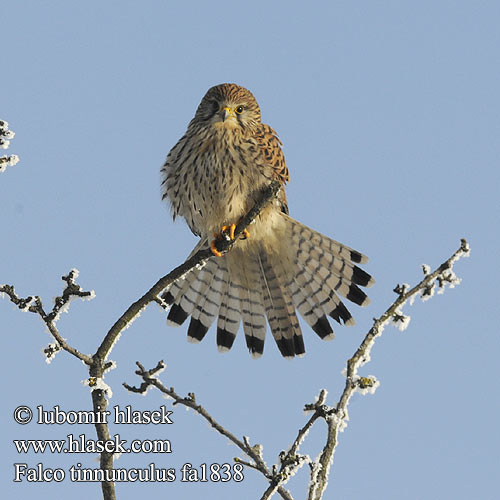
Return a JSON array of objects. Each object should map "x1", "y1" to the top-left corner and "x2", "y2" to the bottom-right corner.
[{"x1": 124, "y1": 239, "x2": 469, "y2": 500}]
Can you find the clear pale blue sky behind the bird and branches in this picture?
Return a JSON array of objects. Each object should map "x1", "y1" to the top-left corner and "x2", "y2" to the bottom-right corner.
[{"x1": 0, "y1": 1, "x2": 500, "y2": 500}]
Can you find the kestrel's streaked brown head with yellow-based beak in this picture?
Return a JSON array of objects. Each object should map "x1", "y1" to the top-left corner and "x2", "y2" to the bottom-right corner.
[{"x1": 193, "y1": 83, "x2": 261, "y2": 131}]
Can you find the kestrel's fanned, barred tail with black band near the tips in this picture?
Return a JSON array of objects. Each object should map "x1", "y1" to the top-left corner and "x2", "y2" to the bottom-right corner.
[{"x1": 161, "y1": 213, "x2": 374, "y2": 357}]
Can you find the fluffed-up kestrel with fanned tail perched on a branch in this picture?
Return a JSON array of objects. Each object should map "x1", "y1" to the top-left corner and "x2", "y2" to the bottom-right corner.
[{"x1": 162, "y1": 83, "x2": 374, "y2": 357}]
